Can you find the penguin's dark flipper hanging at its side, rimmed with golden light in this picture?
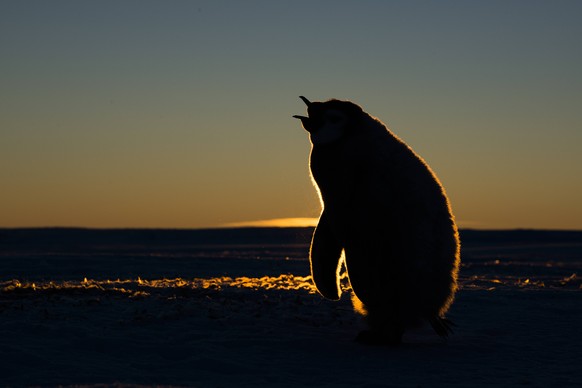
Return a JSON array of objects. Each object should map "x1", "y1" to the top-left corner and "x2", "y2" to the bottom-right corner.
[{"x1": 309, "y1": 210, "x2": 343, "y2": 300}]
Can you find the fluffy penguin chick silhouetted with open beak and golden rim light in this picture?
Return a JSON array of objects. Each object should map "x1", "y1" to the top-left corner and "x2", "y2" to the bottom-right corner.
[{"x1": 293, "y1": 96, "x2": 460, "y2": 345}]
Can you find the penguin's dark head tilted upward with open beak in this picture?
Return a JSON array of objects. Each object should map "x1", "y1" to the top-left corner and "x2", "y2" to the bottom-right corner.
[{"x1": 293, "y1": 96, "x2": 362, "y2": 145}]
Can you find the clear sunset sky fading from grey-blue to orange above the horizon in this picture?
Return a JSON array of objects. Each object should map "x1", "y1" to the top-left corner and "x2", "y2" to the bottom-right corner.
[{"x1": 0, "y1": 0, "x2": 582, "y2": 229}]
